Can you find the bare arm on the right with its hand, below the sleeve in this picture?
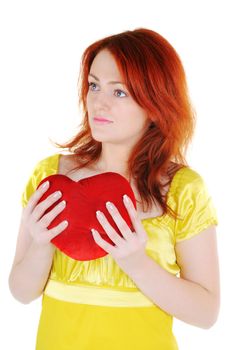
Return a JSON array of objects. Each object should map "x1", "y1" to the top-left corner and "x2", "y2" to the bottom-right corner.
[{"x1": 93, "y1": 197, "x2": 220, "y2": 328}]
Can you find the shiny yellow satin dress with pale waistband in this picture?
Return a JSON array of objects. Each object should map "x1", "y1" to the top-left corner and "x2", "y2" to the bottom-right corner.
[{"x1": 21, "y1": 153, "x2": 217, "y2": 350}]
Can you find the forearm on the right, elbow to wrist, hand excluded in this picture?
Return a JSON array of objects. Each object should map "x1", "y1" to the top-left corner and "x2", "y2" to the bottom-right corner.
[{"x1": 130, "y1": 255, "x2": 218, "y2": 328}]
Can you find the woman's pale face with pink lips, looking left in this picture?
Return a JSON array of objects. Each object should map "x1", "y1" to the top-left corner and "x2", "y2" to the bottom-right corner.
[{"x1": 87, "y1": 50, "x2": 150, "y2": 145}]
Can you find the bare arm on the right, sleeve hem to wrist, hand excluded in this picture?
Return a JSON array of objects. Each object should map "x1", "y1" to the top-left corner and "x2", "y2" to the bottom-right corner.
[{"x1": 127, "y1": 226, "x2": 220, "y2": 328}]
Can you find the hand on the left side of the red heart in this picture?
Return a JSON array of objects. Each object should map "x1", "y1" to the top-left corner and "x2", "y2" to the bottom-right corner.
[{"x1": 21, "y1": 182, "x2": 68, "y2": 246}]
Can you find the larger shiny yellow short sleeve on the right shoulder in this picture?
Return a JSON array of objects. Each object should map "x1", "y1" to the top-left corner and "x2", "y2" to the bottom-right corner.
[{"x1": 175, "y1": 168, "x2": 218, "y2": 242}]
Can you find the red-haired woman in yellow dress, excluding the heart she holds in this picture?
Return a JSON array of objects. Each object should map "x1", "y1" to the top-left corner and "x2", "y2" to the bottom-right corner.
[{"x1": 9, "y1": 28, "x2": 220, "y2": 350}]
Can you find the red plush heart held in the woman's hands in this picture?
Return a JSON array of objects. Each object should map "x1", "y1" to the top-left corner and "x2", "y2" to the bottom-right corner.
[{"x1": 37, "y1": 172, "x2": 136, "y2": 260}]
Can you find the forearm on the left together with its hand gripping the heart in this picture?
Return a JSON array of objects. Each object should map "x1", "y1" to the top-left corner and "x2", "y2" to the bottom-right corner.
[{"x1": 9, "y1": 182, "x2": 67, "y2": 304}]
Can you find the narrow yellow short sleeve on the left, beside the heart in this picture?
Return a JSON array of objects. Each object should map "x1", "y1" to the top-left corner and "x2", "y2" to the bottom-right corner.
[{"x1": 21, "y1": 154, "x2": 59, "y2": 208}]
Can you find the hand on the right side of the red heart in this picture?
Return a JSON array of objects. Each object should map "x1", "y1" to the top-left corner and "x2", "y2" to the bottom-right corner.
[{"x1": 91, "y1": 196, "x2": 148, "y2": 274}]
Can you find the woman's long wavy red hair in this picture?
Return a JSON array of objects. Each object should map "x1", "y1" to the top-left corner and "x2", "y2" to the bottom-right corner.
[{"x1": 51, "y1": 28, "x2": 195, "y2": 218}]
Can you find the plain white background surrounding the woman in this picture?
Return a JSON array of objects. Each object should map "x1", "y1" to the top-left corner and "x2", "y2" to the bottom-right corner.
[{"x1": 0, "y1": 0, "x2": 232, "y2": 350}]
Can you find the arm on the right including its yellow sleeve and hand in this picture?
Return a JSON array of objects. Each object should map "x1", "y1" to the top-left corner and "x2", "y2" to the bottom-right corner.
[{"x1": 93, "y1": 171, "x2": 220, "y2": 328}]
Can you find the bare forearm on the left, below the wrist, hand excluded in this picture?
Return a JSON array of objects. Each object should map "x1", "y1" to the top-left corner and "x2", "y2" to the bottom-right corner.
[{"x1": 9, "y1": 243, "x2": 54, "y2": 304}]
